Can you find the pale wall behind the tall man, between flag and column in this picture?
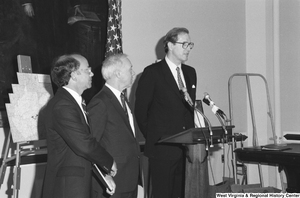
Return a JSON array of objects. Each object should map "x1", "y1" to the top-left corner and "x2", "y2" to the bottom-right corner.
[{"x1": 122, "y1": 0, "x2": 246, "y2": 128}]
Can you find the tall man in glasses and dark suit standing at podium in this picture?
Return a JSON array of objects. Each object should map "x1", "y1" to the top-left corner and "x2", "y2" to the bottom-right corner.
[{"x1": 135, "y1": 28, "x2": 197, "y2": 198}]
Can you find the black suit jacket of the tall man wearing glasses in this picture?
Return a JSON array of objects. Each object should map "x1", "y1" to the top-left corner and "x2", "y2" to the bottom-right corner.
[{"x1": 135, "y1": 59, "x2": 197, "y2": 159}]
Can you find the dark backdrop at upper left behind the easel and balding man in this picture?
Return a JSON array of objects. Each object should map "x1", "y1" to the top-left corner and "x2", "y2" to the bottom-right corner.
[{"x1": 0, "y1": 0, "x2": 108, "y2": 110}]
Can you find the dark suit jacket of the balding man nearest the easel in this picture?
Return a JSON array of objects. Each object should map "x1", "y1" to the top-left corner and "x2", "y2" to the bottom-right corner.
[{"x1": 42, "y1": 88, "x2": 113, "y2": 198}]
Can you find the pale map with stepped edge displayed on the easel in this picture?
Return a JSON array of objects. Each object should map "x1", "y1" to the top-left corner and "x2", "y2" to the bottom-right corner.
[{"x1": 5, "y1": 73, "x2": 53, "y2": 143}]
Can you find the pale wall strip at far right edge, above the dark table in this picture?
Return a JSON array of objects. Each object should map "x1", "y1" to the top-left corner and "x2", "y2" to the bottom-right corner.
[{"x1": 279, "y1": 0, "x2": 300, "y2": 133}]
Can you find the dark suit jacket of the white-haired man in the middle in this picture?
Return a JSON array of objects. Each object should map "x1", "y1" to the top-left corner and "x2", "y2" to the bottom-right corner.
[{"x1": 88, "y1": 86, "x2": 140, "y2": 193}]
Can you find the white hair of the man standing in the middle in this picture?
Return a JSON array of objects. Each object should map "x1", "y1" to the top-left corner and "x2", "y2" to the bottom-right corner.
[{"x1": 101, "y1": 54, "x2": 128, "y2": 81}]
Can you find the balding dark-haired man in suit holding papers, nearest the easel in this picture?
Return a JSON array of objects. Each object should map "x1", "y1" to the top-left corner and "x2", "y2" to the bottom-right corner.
[{"x1": 42, "y1": 54, "x2": 117, "y2": 198}]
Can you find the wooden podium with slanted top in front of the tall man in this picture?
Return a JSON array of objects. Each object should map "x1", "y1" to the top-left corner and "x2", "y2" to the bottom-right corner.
[{"x1": 158, "y1": 126, "x2": 234, "y2": 198}]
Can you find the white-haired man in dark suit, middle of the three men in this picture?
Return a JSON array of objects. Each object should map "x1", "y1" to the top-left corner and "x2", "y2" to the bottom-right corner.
[{"x1": 88, "y1": 54, "x2": 140, "y2": 198}]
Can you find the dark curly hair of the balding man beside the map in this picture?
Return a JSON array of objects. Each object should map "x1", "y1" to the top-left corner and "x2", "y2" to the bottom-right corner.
[{"x1": 51, "y1": 54, "x2": 81, "y2": 87}]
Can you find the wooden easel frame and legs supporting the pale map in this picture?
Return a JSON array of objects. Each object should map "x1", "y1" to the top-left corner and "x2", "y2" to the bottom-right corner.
[{"x1": 0, "y1": 55, "x2": 52, "y2": 198}]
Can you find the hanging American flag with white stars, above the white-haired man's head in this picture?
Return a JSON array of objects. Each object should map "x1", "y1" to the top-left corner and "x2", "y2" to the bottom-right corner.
[{"x1": 105, "y1": 0, "x2": 123, "y2": 57}]
